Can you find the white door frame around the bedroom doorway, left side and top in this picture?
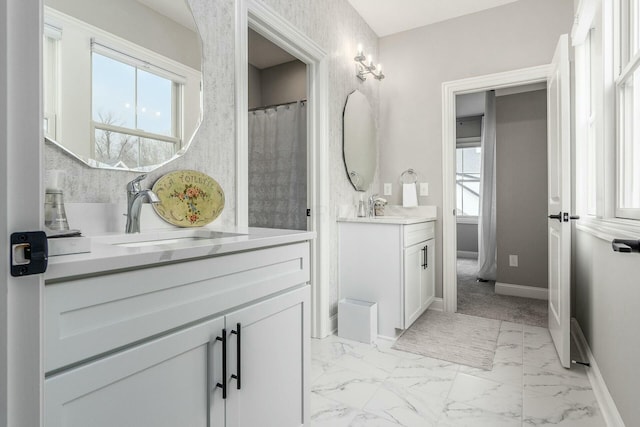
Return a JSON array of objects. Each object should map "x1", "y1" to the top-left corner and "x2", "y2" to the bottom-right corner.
[{"x1": 442, "y1": 65, "x2": 549, "y2": 313}]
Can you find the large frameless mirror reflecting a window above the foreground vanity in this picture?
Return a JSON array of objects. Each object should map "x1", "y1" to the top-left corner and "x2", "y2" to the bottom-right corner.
[{"x1": 43, "y1": 0, "x2": 202, "y2": 172}]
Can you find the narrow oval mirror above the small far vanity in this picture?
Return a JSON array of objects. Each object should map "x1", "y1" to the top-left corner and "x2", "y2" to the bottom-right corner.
[{"x1": 342, "y1": 90, "x2": 378, "y2": 191}]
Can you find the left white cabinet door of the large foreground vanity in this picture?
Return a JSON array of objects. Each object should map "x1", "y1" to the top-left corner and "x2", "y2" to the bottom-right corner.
[{"x1": 45, "y1": 318, "x2": 225, "y2": 427}]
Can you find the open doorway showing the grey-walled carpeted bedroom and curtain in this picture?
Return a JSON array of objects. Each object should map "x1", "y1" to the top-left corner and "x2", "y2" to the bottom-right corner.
[{"x1": 456, "y1": 87, "x2": 548, "y2": 327}]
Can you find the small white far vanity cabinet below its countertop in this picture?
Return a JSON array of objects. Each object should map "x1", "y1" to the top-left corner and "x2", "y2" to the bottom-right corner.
[{"x1": 339, "y1": 217, "x2": 435, "y2": 338}]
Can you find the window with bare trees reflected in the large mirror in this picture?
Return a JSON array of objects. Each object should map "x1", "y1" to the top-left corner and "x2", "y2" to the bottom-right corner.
[{"x1": 91, "y1": 43, "x2": 182, "y2": 168}]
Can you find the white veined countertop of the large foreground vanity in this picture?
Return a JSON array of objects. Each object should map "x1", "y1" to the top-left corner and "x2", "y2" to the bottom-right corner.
[{"x1": 45, "y1": 227, "x2": 315, "y2": 281}]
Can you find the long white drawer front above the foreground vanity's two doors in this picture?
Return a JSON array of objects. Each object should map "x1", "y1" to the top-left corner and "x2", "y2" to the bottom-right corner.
[{"x1": 44, "y1": 242, "x2": 309, "y2": 372}]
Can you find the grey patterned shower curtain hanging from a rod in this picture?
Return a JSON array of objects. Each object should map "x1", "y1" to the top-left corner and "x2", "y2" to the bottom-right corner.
[{"x1": 249, "y1": 101, "x2": 307, "y2": 230}]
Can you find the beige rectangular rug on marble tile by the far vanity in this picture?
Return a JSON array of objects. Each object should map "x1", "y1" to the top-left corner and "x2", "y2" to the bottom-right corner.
[{"x1": 393, "y1": 310, "x2": 500, "y2": 371}]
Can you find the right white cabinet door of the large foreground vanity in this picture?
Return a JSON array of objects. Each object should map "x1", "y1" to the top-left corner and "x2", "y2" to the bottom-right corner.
[{"x1": 226, "y1": 286, "x2": 310, "y2": 427}]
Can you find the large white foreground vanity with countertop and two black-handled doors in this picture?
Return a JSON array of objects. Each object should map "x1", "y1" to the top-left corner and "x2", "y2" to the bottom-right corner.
[{"x1": 44, "y1": 229, "x2": 313, "y2": 427}]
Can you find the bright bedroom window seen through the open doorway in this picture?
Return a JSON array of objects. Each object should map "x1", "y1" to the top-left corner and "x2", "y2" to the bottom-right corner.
[{"x1": 456, "y1": 146, "x2": 482, "y2": 217}]
